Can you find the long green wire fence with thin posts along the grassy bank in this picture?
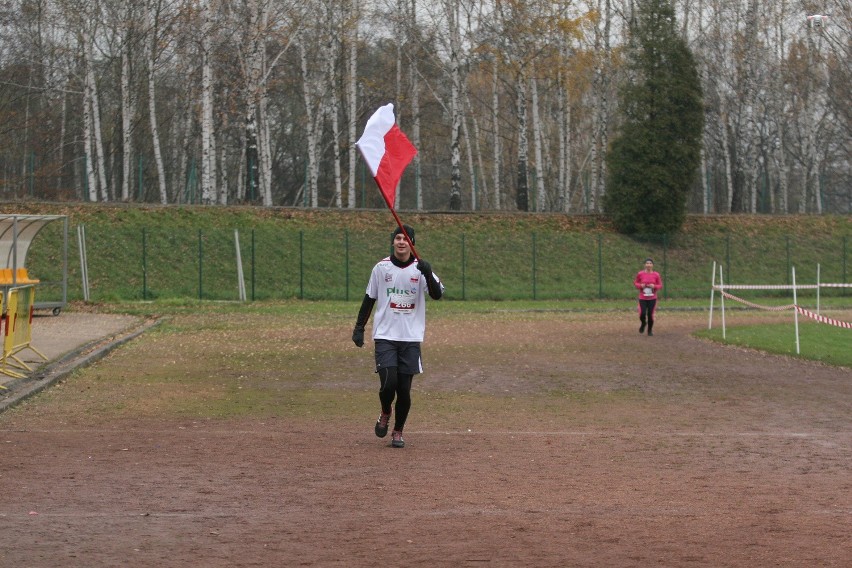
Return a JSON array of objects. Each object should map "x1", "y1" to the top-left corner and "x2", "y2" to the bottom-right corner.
[{"x1": 27, "y1": 225, "x2": 849, "y2": 301}]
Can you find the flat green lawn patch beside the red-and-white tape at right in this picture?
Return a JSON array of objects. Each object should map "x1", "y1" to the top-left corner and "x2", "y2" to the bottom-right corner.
[{"x1": 696, "y1": 317, "x2": 852, "y2": 367}]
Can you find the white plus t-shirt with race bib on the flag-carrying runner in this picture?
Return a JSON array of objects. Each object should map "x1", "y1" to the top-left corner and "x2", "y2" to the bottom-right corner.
[{"x1": 367, "y1": 257, "x2": 443, "y2": 342}]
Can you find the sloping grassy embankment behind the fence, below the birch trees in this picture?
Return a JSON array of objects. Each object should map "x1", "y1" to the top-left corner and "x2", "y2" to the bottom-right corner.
[{"x1": 4, "y1": 204, "x2": 852, "y2": 305}]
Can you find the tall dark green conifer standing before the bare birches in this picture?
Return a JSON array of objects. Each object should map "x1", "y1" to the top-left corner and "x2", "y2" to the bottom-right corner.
[{"x1": 604, "y1": 0, "x2": 704, "y2": 235}]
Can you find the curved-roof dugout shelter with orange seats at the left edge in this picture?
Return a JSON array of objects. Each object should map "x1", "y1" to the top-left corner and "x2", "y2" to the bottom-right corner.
[{"x1": 0, "y1": 215, "x2": 68, "y2": 316}]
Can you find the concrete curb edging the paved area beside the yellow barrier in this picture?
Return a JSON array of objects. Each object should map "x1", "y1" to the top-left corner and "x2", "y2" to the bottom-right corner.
[{"x1": 0, "y1": 319, "x2": 160, "y2": 412}]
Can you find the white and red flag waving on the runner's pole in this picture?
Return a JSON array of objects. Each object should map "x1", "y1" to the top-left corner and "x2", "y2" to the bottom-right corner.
[{"x1": 355, "y1": 103, "x2": 417, "y2": 210}]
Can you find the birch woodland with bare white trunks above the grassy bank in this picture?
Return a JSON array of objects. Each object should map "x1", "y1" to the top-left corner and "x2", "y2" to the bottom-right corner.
[{"x1": 0, "y1": 0, "x2": 852, "y2": 214}]
